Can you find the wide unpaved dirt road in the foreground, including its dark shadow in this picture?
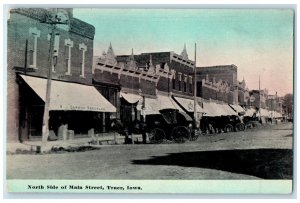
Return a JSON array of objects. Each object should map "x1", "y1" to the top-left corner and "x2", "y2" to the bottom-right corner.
[{"x1": 6, "y1": 123, "x2": 293, "y2": 180}]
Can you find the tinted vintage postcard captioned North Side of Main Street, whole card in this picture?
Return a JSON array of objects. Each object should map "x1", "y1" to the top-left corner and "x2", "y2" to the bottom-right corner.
[{"x1": 5, "y1": 6, "x2": 295, "y2": 194}]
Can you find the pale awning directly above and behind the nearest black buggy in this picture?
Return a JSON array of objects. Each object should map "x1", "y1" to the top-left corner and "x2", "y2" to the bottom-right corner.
[{"x1": 144, "y1": 95, "x2": 183, "y2": 115}]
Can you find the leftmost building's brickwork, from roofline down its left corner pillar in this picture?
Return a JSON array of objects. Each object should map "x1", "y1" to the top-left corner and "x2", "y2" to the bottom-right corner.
[{"x1": 7, "y1": 9, "x2": 95, "y2": 142}]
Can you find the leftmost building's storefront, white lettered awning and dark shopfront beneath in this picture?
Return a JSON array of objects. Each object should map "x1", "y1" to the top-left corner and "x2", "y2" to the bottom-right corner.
[{"x1": 19, "y1": 75, "x2": 116, "y2": 141}]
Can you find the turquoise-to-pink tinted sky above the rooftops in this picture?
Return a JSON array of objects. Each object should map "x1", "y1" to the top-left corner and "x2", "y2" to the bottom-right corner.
[{"x1": 73, "y1": 8, "x2": 294, "y2": 96}]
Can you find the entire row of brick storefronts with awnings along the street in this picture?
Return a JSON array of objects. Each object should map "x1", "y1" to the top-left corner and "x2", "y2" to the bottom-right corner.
[{"x1": 7, "y1": 9, "x2": 280, "y2": 142}]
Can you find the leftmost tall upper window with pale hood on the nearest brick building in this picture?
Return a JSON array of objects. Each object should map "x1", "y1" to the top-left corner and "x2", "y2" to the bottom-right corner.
[{"x1": 29, "y1": 27, "x2": 41, "y2": 68}]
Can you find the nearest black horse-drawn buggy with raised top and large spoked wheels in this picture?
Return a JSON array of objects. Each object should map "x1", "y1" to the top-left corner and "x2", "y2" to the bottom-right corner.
[{"x1": 145, "y1": 109, "x2": 199, "y2": 143}]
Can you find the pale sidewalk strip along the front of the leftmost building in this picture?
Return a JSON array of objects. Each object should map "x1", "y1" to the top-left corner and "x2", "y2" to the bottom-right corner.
[{"x1": 6, "y1": 133, "x2": 142, "y2": 154}]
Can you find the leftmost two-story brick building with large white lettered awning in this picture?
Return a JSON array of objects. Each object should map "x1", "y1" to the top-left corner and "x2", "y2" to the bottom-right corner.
[{"x1": 7, "y1": 8, "x2": 115, "y2": 141}]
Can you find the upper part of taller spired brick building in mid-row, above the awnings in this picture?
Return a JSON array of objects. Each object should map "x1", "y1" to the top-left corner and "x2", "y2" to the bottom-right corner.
[{"x1": 116, "y1": 46, "x2": 194, "y2": 97}]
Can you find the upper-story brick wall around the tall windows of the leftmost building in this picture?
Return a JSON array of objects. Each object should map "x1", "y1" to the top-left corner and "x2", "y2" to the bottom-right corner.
[{"x1": 8, "y1": 13, "x2": 93, "y2": 84}]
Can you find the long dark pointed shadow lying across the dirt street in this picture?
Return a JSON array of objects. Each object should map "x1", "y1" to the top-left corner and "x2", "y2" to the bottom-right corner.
[{"x1": 132, "y1": 149, "x2": 293, "y2": 179}]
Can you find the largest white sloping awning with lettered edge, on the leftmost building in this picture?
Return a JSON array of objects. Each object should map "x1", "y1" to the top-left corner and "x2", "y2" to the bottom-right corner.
[{"x1": 20, "y1": 75, "x2": 116, "y2": 112}]
